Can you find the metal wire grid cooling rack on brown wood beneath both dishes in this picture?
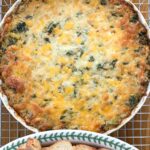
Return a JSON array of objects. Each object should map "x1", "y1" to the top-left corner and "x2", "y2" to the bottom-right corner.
[{"x1": 0, "y1": 0, "x2": 150, "y2": 150}]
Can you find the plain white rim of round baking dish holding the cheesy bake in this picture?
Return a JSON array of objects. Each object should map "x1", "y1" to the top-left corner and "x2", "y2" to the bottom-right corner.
[{"x1": 0, "y1": 0, "x2": 150, "y2": 134}]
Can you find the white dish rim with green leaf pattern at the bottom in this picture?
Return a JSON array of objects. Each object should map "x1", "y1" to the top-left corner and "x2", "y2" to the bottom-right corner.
[{"x1": 0, "y1": 130, "x2": 138, "y2": 150}]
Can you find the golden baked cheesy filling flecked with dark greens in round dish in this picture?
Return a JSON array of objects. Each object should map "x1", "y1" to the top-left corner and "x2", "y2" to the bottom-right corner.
[{"x1": 0, "y1": 0, "x2": 150, "y2": 132}]
